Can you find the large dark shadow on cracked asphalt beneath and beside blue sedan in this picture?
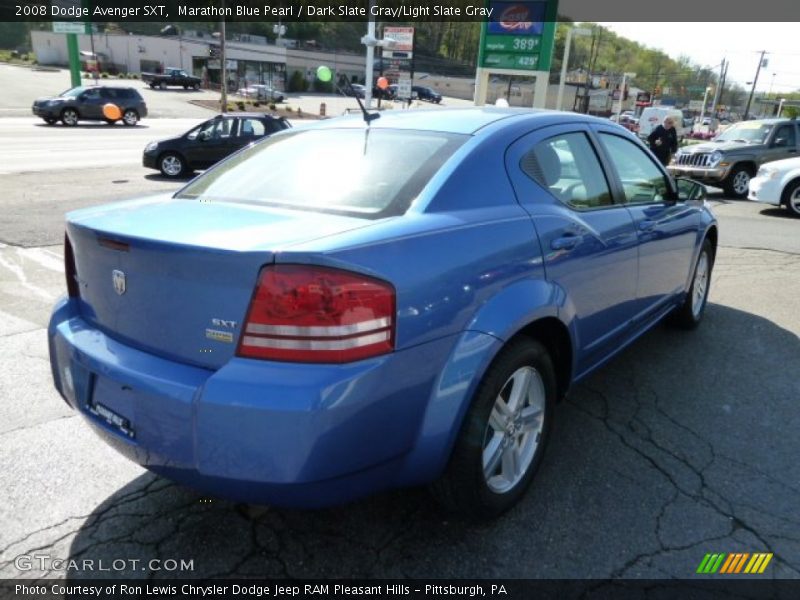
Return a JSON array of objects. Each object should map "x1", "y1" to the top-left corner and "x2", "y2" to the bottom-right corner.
[{"x1": 68, "y1": 304, "x2": 800, "y2": 579}]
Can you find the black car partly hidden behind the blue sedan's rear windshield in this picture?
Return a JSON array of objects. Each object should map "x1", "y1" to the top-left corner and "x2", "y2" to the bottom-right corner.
[{"x1": 142, "y1": 113, "x2": 289, "y2": 177}]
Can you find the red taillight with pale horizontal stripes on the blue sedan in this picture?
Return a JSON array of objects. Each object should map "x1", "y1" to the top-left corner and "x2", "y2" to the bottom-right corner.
[{"x1": 237, "y1": 265, "x2": 395, "y2": 363}]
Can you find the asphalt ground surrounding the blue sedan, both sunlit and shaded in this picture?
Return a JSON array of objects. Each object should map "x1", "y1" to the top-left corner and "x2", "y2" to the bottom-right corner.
[{"x1": 0, "y1": 66, "x2": 800, "y2": 579}]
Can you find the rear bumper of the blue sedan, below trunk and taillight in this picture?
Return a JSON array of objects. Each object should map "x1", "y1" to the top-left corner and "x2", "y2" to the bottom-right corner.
[{"x1": 48, "y1": 299, "x2": 471, "y2": 507}]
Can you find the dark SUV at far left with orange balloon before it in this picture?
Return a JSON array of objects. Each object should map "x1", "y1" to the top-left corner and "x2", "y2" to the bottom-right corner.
[{"x1": 32, "y1": 86, "x2": 147, "y2": 127}]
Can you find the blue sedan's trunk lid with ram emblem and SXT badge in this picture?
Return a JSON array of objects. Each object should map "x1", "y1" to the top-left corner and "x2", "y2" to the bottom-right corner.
[{"x1": 67, "y1": 197, "x2": 367, "y2": 368}]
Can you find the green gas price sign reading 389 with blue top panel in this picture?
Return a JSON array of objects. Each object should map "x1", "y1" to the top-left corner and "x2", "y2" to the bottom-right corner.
[{"x1": 478, "y1": 0, "x2": 558, "y2": 71}]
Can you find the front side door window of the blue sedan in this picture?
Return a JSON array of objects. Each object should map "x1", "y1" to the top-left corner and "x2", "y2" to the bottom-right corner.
[{"x1": 600, "y1": 133, "x2": 670, "y2": 204}]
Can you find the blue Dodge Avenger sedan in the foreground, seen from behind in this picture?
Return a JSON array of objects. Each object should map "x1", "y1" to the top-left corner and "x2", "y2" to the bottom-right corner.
[{"x1": 48, "y1": 108, "x2": 718, "y2": 518}]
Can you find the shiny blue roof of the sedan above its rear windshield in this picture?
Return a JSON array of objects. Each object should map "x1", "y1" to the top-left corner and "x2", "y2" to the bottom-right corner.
[{"x1": 316, "y1": 106, "x2": 607, "y2": 135}]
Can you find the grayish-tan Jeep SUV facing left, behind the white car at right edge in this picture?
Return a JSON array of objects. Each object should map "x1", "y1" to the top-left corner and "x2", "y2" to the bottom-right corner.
[{"x1": 669, "y1": 119, "x2": 800, "y2": 198}]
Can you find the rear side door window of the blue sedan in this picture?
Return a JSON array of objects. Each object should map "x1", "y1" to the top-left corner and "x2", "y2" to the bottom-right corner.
[{"x1": 520, "y1": 133, "x2": 613, "y2": 210}]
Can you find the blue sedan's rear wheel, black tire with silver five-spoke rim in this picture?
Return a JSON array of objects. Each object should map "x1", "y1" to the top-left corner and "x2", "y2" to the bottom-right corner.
[{"x1": 431, "y1": 337, "x2": 557, "y2": 520}]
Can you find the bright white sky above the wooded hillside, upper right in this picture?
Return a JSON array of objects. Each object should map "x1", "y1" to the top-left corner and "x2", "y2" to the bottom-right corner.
[{"x1": 600, "y1": 23, "x2": 800, "y2": 94}]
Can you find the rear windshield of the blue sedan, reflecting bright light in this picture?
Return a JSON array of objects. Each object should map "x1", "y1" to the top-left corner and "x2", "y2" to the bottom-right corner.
[{"x1": 176, "y1": 129, "x2": 468, "y2": 218}]
